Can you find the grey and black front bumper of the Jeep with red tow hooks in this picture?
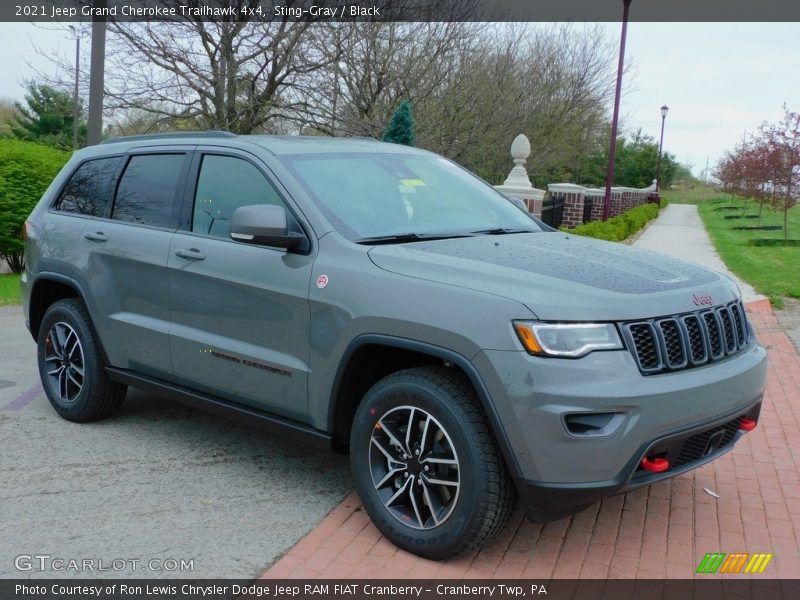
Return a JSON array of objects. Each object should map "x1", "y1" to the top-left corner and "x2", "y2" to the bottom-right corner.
[{"x1": 473, "y1": 339, "x2": 766, "y2": 521}]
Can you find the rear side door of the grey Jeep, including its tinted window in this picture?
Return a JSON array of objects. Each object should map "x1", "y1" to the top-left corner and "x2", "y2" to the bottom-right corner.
[{"x1": 83, "y1": 147, "x2": 191, "y2": 378}]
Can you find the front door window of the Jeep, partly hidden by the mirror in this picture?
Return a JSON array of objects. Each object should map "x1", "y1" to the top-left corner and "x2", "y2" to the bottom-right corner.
[{"x1": 192, "y1": 154, "x2": 284, "y2": 238}]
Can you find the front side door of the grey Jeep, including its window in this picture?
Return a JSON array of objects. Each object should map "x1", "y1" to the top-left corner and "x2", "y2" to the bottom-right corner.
[{"x1": 168, "y1": 149, "x2": 314, "y2": 420}]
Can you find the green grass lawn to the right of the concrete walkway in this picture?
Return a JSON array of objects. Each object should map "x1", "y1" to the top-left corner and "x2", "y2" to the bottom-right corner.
[{"x1": 665, "y1": 188, "x2": 800, "y2": 308}]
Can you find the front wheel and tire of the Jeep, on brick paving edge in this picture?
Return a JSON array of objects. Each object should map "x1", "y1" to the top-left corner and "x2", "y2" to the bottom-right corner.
[{"x1": 350, "y1": 367, "x2": 516, "y2": 560}]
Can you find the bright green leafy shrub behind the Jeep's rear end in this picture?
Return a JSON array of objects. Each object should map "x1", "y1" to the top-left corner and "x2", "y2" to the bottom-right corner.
[{"x1": 0, "y1": 139, "x2": 70, "y2": 273}]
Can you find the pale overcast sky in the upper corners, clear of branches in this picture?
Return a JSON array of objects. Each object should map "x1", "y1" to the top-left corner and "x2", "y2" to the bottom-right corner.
[{"x1": 0, "y1": 22, "x2": 800, "y2": 175}]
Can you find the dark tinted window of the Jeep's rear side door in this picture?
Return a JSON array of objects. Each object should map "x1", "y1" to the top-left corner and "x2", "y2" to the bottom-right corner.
[{"x1": 113, "y1": 154, "x2": 185, "y2": 227}]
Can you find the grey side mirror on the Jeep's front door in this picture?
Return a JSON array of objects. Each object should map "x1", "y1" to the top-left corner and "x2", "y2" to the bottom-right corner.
[{"x1": 230, "y1": 204, "x2": 306, "y2": 250}]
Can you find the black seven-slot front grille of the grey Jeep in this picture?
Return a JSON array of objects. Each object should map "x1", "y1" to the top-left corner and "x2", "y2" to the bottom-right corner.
[{"x1": 621, "y1": 301, "x2": 750, "y2": 375}]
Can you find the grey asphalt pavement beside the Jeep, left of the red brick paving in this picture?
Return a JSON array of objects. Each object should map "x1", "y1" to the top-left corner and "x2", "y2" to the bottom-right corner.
[{"x1": 0, "y1": 306, "x2": 353, "y2": 578}]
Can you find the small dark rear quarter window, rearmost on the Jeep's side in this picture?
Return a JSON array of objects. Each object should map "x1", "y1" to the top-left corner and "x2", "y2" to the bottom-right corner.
[{"x1": 55, "y1": 156, "x2": 121, "y2": 217}]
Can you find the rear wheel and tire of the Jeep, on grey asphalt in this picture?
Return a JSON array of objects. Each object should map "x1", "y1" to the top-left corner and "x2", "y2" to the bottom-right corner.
[{"x1": 37, "y1": 298, "x2": 127, "y2": 423}]
